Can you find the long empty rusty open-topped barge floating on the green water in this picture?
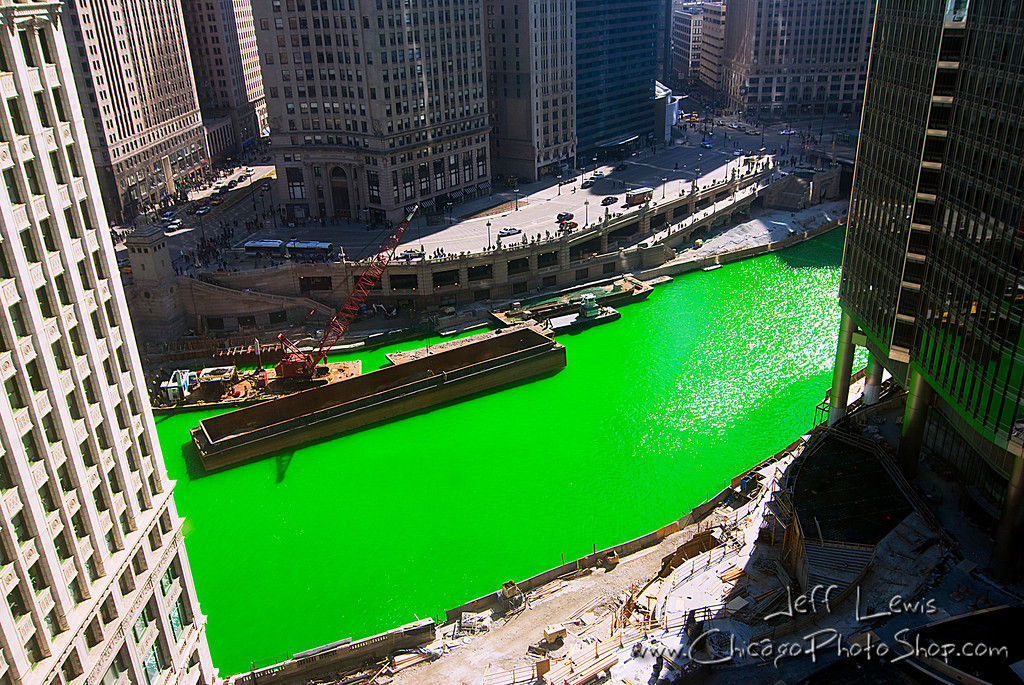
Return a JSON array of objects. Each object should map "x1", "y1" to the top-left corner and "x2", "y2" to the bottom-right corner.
[{"x1": 191, "y1": 328, "x2": 565, "y2": 472}]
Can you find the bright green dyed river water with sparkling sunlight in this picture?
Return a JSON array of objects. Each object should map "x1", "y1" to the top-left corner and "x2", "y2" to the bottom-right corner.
[{"x1": 151, "y1": 230, "x2": 860, "y2": 675}]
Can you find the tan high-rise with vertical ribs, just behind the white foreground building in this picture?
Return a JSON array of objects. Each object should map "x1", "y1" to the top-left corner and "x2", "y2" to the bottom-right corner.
[{"x1": 61, "y1": 0, "x2": 209, "y2": 221}]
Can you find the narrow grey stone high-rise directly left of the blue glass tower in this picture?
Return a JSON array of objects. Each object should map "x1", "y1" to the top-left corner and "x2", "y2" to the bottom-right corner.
[{"x1": 484, "y1": 0, "x2": 575, "y2": 180}]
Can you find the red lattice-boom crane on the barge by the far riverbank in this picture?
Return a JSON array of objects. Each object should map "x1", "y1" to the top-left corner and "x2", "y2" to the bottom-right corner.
[{"x1": 274, "y1": 205, "x2": 420, "y2": 378}]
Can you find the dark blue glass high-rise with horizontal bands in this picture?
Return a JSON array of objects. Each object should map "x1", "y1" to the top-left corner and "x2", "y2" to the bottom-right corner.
[{"x1": 575, "y1": 0, "x2": 663, "y2": 163}]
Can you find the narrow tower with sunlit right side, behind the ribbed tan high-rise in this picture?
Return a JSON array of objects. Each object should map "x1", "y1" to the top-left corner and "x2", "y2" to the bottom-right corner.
[{"x1": 181, "y1": 0, "x2": 266, "y2": 158}]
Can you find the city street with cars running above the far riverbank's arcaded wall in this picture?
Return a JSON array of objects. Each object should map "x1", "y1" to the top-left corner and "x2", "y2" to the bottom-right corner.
[{"x1": 125, "y1": 116, "x2": 856, "y2": 268}]
